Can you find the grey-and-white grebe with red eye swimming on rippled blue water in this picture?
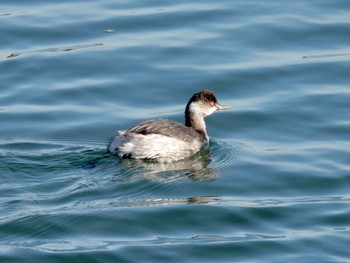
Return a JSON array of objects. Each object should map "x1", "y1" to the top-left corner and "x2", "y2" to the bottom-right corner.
[{"x1": 108, "y1": 90, "x2": 228, "y2": 162}]
